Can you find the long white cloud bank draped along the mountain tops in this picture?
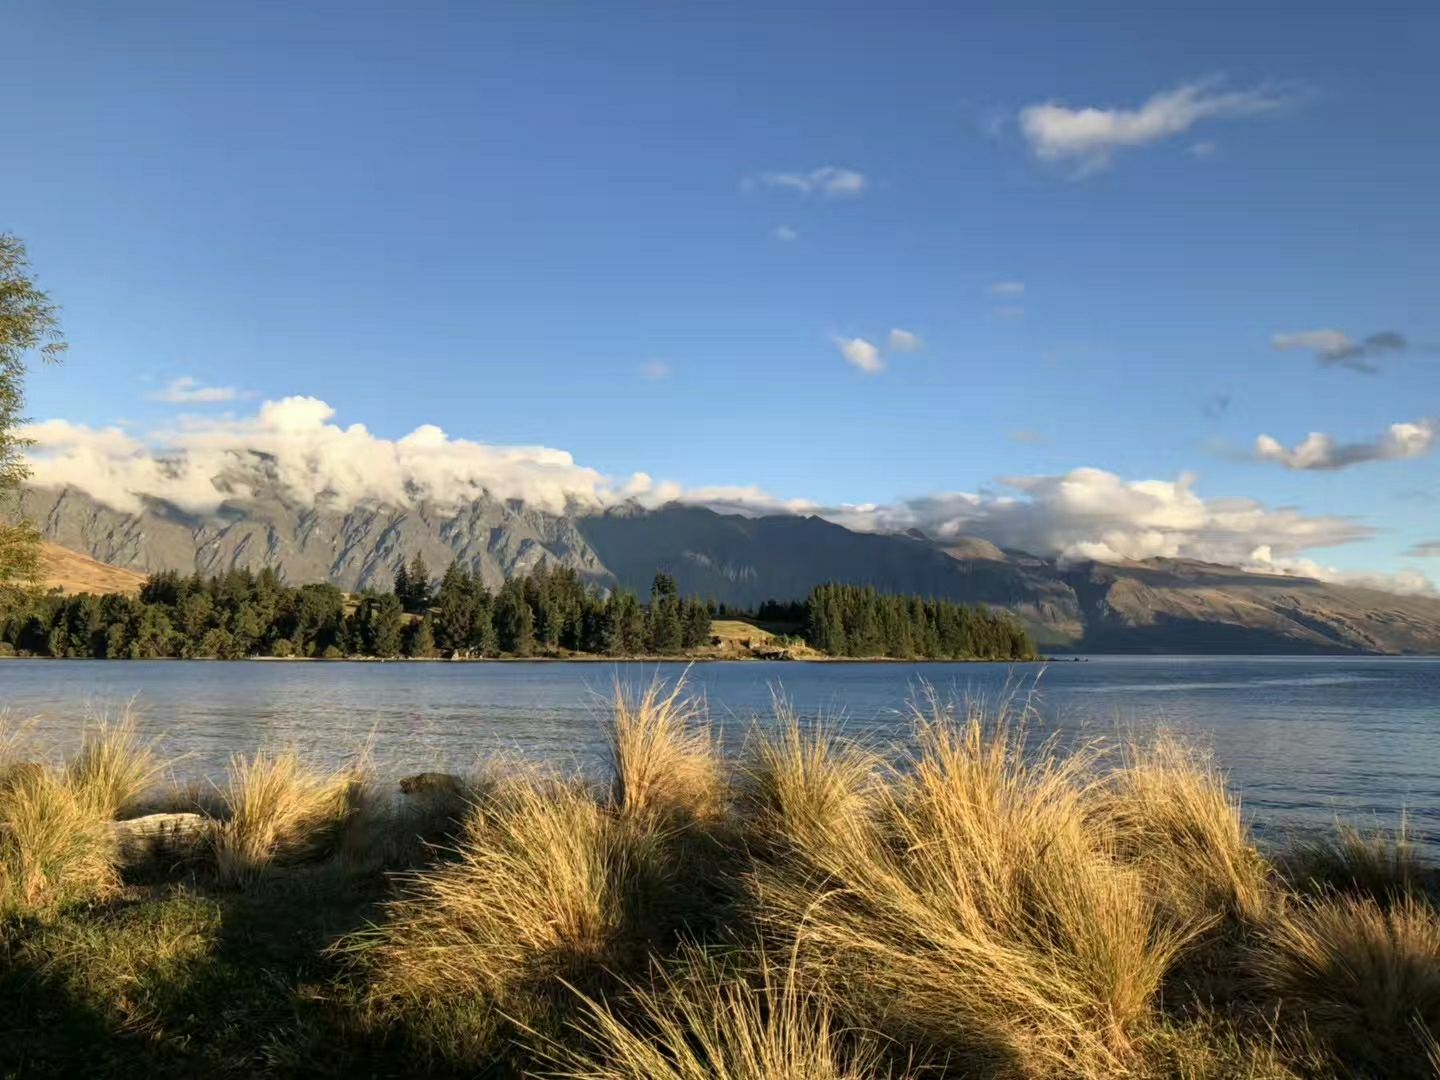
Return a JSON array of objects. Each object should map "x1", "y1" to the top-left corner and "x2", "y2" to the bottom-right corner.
[{"x1": 27, "y1": 397, "x2": 1411, "y2": 593}]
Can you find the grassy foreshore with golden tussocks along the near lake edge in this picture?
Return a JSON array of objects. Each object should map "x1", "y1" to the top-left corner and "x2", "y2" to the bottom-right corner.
[{"x1": 0, "y1": 687, "x2": 1440, "y2": 1080}]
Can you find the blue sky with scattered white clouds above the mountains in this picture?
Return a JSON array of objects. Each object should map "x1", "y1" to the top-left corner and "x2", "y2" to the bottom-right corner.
[{"x1": 0, "y1": 0, "x2": 1440, "y2": 590}]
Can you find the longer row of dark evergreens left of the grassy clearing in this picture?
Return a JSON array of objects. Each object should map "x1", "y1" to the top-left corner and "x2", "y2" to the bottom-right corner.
[{"x1": 0, "y1": 557, "x2": 716, "y2": 660}]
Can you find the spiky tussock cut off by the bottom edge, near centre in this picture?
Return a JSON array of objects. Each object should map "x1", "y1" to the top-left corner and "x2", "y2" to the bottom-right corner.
[{"x1": 547, "y1": 949, "x2": 904, "y2": 1080}]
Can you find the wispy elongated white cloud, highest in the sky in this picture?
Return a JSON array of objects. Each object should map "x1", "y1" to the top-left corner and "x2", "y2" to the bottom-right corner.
[{"x1": 1020, "y1": 78, "x2": 1296, "y2": 173}]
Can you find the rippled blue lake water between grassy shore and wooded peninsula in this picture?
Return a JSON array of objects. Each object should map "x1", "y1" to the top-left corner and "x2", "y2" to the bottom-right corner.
[{"x1": 0, "y1": 657, "x2": 1440, "y2": 848}]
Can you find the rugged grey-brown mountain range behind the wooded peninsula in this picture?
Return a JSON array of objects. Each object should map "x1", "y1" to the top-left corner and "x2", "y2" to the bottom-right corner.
[{"x1": 22, "y1": 487, "x2": 1440, "y2": 654}]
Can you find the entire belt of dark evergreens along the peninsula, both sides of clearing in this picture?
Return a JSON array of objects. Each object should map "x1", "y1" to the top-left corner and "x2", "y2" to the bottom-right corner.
[{"x1": 0, "y1": 556, "x2": 1035, "y2": 660}]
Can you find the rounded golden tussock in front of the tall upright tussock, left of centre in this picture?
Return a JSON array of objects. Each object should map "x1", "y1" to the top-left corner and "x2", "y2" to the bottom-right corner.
[{"x1": 361, "y1": 775, "x2": 671, "y2": 1048}]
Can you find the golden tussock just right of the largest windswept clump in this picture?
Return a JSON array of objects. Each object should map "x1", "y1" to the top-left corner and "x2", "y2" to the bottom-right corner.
[{"x1": 1094, "y1": 734, "x2": 1277, "y2": 923}]
